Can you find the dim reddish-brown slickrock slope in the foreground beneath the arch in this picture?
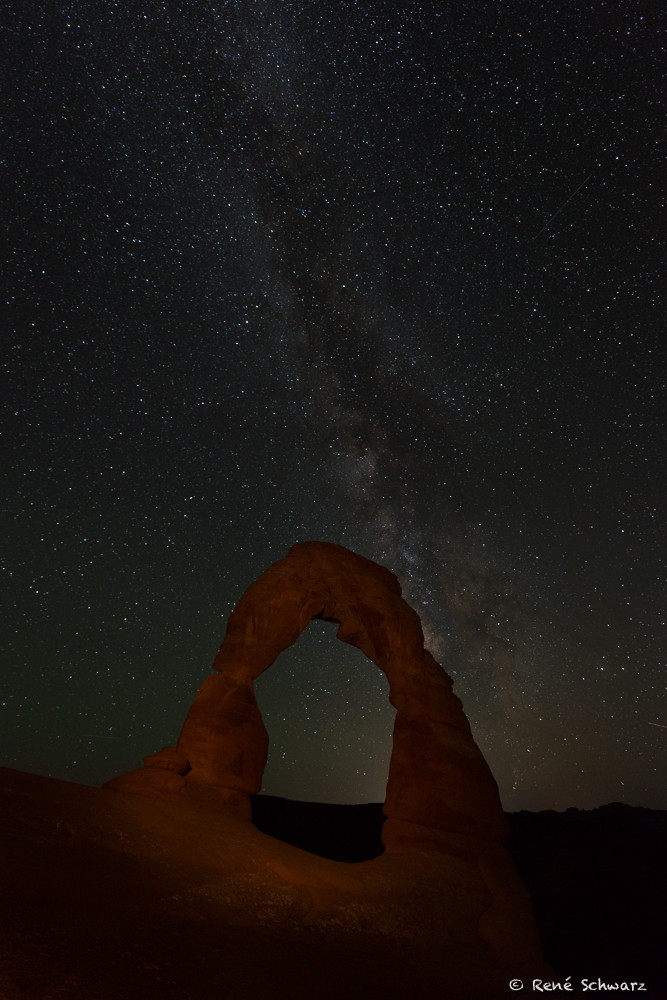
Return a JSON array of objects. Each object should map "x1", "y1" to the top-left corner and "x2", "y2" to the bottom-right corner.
[{"x1": 0, "y1": 769, "x2": 548, "y2": 1000}]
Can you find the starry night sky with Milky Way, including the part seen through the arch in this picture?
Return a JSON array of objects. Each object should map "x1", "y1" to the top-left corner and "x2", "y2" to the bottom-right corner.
[{"x1": 0, "y1": 0, "x2": 667, "y2": 810}]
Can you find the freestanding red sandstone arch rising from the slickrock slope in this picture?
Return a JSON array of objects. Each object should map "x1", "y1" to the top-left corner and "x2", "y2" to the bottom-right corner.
[{"x1": 108, "y1": 542, "x2": 507, "y2": 851}]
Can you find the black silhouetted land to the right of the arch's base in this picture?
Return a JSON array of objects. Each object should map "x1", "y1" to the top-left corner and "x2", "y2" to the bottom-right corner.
[{"x1": 507, "y1": 802, "x2": 667, "y2": 997}]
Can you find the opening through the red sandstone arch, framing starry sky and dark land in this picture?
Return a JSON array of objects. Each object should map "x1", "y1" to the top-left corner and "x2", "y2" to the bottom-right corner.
[{"x1": 252, "y1": 618, "x2": 396, "y2": 862}]
